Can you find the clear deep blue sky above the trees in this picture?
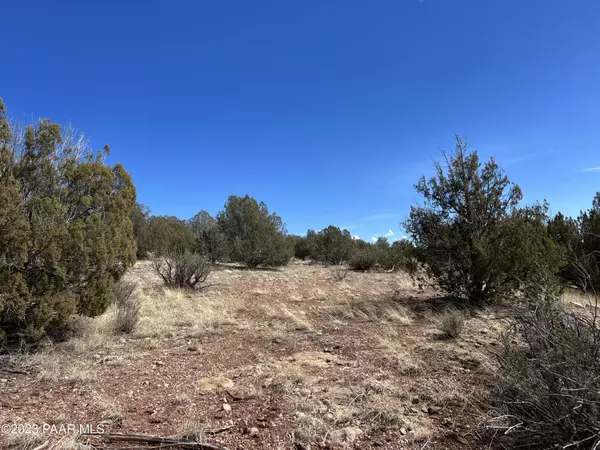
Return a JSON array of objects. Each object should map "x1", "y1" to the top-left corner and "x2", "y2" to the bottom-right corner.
[{"x1": 0, "y1": 0, "x2": 600, "y2": 240}]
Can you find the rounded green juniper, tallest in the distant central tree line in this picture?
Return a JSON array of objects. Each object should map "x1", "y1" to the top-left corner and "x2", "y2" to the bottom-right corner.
[{"x1": 217, "y1": 195, "x2": 292, "y2": 268}]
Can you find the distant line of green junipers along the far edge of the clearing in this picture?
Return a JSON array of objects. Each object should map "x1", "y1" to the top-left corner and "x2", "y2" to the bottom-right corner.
[{"x1": 131, "y1": 206, "x2": 414, "y2": 271}]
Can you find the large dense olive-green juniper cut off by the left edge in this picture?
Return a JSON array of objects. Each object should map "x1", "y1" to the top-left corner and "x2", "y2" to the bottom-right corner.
[{"x1": 0, "y1": 96, "x2": 136, "y2": 339}]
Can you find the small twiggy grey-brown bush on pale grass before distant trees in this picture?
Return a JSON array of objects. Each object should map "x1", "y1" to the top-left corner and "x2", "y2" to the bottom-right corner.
[{"x1": 154, "y1": 252, "x2": 212, "y2": 289}]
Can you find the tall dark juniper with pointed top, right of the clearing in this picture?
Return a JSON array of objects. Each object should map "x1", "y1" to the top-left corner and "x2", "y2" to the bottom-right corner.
[{"x1": 405, "y1": 137, "x2": 560, "y2": 302}]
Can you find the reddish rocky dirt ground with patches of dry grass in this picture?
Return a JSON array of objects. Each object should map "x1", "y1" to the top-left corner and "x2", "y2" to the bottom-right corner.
[{"x1": 0, "y1": 261, "x2": 502, "y2": 450}]
